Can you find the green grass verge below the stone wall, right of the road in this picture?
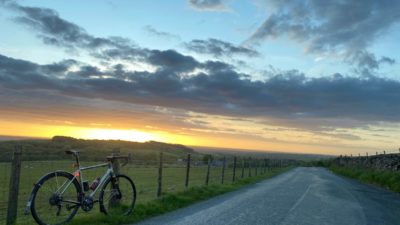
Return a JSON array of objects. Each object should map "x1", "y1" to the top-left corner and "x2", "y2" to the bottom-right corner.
[{"x1": 328, "y1": 166, "x2": 400, "y2": 193}]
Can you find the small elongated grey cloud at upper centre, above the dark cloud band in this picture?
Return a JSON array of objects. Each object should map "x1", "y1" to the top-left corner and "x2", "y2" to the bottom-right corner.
[{"x1": 185, "y1": 38, "x2": 260, "y2": 57}]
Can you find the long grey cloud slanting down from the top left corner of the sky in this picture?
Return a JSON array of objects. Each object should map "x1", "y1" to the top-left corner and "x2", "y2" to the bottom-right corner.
[{"x1": 4, "y1": 1, "x2": 148, "y2": 60}]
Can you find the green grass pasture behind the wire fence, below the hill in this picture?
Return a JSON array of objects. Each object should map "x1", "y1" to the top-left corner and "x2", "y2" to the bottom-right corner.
[{"x1": 0, "y1": 158, "x2": 253, "y2": 224}]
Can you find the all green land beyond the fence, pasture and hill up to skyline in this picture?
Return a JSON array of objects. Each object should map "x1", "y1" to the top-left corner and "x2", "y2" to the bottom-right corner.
[{"x1": 0, "y1": 137, "x2": 295, "y2": 224}]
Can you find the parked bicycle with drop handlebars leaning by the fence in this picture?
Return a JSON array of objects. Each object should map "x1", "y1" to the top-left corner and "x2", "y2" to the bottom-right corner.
[{"x1": 25, "y1": 150, "x2": 136, "y2": 225}]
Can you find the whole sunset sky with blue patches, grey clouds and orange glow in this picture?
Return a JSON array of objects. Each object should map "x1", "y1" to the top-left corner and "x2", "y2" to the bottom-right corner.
[{"x1": 0, "y1": 0, "x2": 400, "y2": 155}]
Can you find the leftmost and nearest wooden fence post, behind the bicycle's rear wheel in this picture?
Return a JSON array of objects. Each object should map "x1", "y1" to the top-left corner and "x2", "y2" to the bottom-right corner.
[{"x1": 7, "y1": 145, "x2": 22, "y2": 225}]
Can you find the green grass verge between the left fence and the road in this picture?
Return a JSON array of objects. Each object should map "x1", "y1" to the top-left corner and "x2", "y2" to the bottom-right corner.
[{"x1": 69, "y1": 167, "x2": 293, "y2": 225}]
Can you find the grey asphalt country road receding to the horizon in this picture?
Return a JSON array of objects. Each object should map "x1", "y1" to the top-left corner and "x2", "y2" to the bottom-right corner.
[{"x1": 136, "y1": 168, "x2": 400, "y2": 225}]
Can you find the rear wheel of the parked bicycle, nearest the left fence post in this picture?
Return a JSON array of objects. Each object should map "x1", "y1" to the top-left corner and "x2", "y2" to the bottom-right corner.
[{"x1": 31, "y1": 171, "x2": 81, "y2": 225}]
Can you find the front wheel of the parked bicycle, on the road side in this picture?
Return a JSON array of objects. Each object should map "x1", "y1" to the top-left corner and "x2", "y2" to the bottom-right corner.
[{"x1": 99, "y1": 174, "x2": 136, "y2": 216}]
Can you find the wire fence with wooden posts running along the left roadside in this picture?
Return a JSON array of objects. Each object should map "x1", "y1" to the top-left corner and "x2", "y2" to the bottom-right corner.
[{"x1": 0, "y1": 147, "x2": 293, "y2": 224}]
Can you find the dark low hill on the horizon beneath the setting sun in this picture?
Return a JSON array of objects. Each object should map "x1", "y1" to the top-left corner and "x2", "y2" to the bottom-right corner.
[{"x1": 0, "y1": 136, "x2": 194, "y2": 162}]
